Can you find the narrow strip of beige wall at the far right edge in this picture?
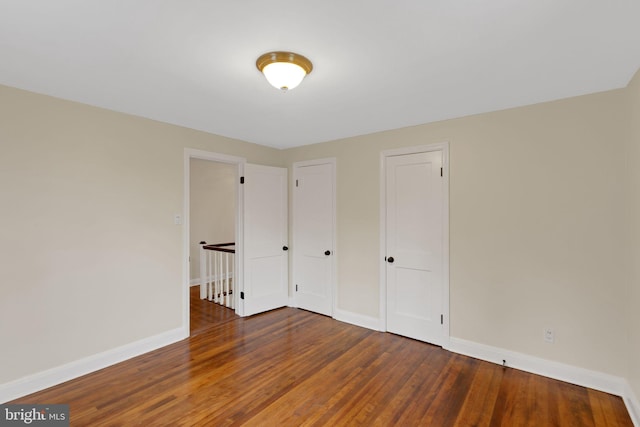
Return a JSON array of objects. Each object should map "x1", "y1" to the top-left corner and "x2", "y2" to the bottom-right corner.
[{"x1": 627, "y1": 71, "x2": 640, "y2": 398}]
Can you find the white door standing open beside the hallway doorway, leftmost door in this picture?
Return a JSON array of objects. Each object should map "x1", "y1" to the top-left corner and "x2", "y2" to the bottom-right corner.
[{"x1": 240, "y1": 164, "x2": 289, "y2": 316}]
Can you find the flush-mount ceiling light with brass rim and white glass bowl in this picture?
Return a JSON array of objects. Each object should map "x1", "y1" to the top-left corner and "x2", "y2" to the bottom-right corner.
[{"x1": 256, "y1": 52, "x2": 313, "y2": 91}]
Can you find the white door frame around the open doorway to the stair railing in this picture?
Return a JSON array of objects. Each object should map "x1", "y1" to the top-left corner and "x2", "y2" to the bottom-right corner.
[{"x1": 182, "y1": 148, "x2": 247, "y2": 336}]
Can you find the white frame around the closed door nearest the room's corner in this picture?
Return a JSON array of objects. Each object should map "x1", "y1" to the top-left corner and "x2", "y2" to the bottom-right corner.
[{"x1": 289, "y1": 157, "x2": 338, "y2": 317}]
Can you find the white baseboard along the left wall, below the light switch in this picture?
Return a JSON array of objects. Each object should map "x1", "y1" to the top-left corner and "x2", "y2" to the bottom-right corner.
[{"x1": 0, "y1": 328, "x2": 189, "y2": 403}]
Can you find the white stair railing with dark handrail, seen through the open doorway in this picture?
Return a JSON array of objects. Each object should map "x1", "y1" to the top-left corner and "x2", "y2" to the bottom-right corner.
[{"x1": 200, "y1": 242, "x2": 236, "y2": 308}]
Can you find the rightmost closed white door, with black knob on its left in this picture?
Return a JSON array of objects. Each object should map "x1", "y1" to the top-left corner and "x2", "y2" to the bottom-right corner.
[{"x1": 385, "y1": 151, "x2": 445, "y2": 345}]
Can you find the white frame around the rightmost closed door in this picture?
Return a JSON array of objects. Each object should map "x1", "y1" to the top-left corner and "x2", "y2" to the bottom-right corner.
[{"x1": 379, "y1": 142, "x2": 450, "y2": 348}]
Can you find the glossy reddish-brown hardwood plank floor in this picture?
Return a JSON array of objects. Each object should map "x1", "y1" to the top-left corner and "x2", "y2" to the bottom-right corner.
[{"x1": 13, "y1": 288, "x2": 632, "y2": 427}]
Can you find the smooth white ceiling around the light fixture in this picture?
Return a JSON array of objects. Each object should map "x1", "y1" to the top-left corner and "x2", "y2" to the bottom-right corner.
[{"x1": 0, "y1": 0, "x2": 640, "y2": 148}]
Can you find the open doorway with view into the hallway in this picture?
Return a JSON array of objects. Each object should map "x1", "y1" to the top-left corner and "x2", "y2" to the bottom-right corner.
[{"x1": 184, "y1": 149, "x2": 244, "y2": 335}]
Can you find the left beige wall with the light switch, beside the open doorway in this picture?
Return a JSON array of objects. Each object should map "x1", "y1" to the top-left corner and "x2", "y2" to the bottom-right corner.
[{"x1": 0, "y1": 86, "x2": 281, "y2": 384}]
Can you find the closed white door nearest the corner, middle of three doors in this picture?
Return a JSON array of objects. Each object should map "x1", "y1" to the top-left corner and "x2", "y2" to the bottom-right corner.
[{"x1": 293, "y1": 161, "x2": 335, "y2": 316}]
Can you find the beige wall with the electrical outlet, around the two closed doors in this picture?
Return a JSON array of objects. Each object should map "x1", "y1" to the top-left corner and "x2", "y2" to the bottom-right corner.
[{"x1": 285, "y1": 91, "x2": 627, "y2": 376}]
